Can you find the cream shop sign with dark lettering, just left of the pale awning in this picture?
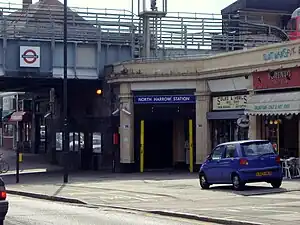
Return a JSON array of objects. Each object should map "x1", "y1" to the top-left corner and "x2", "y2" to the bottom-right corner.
[{"x1": 213, "y1": 95, "x2": 249, "y2": 110}]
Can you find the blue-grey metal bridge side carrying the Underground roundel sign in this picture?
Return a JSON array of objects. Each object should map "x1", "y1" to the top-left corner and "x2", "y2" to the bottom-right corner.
[{"x1": 0, "y1": 38, "x2": 131, "y2": 79}]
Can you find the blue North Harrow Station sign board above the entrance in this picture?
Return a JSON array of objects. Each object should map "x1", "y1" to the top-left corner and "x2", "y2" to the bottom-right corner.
[{"x1": 134, "y1": 95, "x2": 196, "y2": 104}]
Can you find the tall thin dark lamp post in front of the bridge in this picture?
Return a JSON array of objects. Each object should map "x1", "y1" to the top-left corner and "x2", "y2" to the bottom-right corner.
[{"x1": 63, "y1": 0, "x2": 70, "y2": 183}]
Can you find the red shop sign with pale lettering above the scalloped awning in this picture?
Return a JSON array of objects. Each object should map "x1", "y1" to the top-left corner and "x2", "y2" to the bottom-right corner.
[{"x1": 252, "y1": 68, "x2": 300, "y2": 90}]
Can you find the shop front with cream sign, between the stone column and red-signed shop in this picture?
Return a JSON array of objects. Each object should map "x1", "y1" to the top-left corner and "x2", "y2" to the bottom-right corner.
[{"x1": 207, "y1": 94, "x2": 249, "y2": 147}]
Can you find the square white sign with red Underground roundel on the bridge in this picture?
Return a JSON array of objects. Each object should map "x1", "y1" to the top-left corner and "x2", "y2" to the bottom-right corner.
[{"x1": 20, "y1": 46, "x2": 41, "y2": 68}]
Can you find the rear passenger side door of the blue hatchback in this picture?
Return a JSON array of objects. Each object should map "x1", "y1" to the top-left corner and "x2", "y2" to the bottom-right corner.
[{"x1": 219, "y1": 144, "x2": 237, "y2": 183}]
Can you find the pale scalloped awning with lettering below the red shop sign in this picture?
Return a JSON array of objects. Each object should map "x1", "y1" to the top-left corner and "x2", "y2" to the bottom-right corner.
[{"x1": 245, "y1": 92, "x2": 300, "y2": 115}]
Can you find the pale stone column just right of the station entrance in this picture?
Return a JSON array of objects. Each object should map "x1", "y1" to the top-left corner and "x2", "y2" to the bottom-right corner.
[{"x1": 195, "y1": 81, "x2": 212, "y2": 165}]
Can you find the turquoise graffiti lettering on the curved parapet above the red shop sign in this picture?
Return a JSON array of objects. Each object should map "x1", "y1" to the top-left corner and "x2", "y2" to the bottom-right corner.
[{"x1": 263, "y1": 46, "x2": 300, "y2": 61}]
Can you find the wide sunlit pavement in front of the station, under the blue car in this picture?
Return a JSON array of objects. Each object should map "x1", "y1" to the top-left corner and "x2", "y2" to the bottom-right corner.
[{"x1": 3, "y1": 172, "x2": 300, "y2": 224}]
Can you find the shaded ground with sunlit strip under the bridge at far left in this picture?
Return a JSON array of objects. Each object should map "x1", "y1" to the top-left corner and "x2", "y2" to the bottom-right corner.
[{"x1": 0, "y1": 149, "x2": 62, "y2": 176}]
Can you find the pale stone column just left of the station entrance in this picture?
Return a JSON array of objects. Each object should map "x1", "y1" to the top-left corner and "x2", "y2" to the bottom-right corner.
[{"x1": 119, "y1": 83, "x2": 134, "y2": 171}]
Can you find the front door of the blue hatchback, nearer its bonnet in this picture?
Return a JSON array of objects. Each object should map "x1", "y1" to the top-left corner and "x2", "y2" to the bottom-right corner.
[{"x1": 205, "y1": 145, "x2": 224, "y2": 183}]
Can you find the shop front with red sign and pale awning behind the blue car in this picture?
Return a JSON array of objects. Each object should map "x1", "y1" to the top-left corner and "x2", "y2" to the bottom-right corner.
[{"x1": 246, "y1": 68, "x2": 300, "y2": 158}]
